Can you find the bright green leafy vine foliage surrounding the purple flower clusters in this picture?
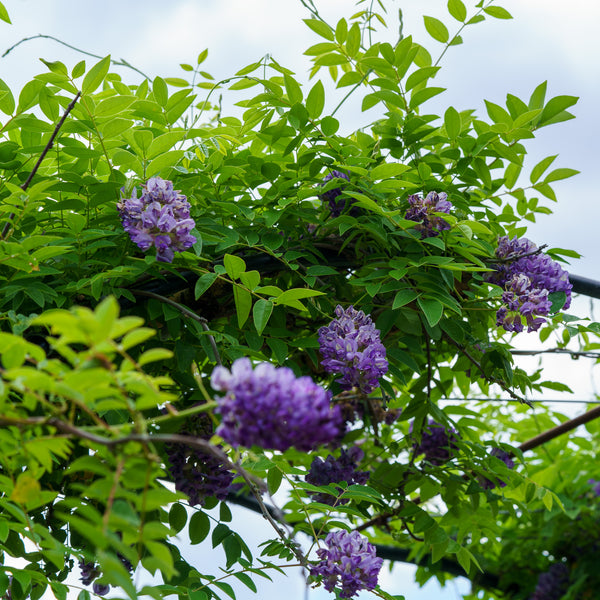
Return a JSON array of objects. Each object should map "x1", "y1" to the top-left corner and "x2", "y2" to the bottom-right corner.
[{"x1": 0, "y1": 0, "x2": 600, "y2": 600}]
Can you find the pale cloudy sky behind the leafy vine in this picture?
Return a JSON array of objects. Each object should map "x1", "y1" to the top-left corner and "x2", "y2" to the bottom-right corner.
[{"x1": 0, "y1": 0, "x2": 600, "y2": 600}]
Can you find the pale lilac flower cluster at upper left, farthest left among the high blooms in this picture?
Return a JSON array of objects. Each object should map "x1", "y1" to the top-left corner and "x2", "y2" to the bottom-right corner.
[{"x1": 117, "y1": 177, "x2": 196, "y2": 262}]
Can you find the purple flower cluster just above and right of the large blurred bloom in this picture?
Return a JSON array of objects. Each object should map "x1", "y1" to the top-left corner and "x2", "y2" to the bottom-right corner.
[{"x1": 319, "y1": 305, "x2": 388, "y2": 394}]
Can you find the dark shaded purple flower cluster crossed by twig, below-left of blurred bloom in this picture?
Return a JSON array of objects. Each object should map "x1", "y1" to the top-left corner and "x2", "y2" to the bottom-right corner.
[{"x1": 165, "y1": 414, "x2": 234, "y2": 506}]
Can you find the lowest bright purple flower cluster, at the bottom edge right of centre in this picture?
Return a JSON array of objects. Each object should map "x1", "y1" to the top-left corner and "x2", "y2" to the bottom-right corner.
[{"x1": 310, "y1": 531, "x2": 383, "y2": 598}]
